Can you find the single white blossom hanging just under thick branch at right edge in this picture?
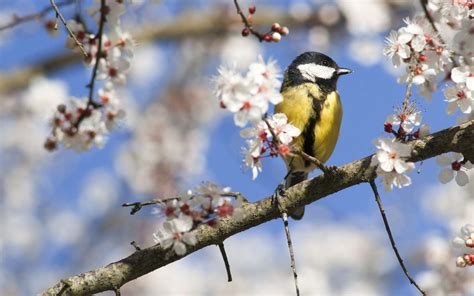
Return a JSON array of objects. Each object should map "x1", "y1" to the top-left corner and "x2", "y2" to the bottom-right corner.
[{"x1": 436, "y1": 152, "x2": 472, "y2": 186}]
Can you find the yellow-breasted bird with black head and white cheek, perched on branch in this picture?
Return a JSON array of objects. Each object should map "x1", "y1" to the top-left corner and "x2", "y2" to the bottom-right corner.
[{"x1": 274, "y1": 51, "x2": 352, "y2": 220}]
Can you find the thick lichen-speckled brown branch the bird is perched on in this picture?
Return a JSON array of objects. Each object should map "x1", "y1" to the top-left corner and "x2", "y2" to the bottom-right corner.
[{"x1": 42, "y1": 120, "x2": 474, "y2": 295}]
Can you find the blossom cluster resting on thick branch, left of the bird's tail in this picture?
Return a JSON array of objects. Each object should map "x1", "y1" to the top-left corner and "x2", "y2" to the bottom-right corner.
[{"x1": 153, "y1": 182, "x2": 243, "y2": 256}]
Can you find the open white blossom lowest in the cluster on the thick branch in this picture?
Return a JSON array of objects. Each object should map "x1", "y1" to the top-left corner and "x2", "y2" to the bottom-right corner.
[{"x1": 153, "y1": 214, "x2": 197, "y2": 256}]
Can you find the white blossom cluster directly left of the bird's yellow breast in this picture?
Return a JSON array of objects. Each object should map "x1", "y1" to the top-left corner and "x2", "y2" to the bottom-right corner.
[{"x1": 215, "y1": 57, "x2": 301, "y2": 179}]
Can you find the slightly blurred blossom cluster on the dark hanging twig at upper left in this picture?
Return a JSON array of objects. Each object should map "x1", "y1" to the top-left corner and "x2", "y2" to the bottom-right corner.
[{"x1": 45, "y1": 0, "x2": 134, "y2": 151}]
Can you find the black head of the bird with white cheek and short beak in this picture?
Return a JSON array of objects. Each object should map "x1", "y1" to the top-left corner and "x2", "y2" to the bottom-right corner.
[{"x1": 283, "y1": 51, "x2": 352, "y2": 92}]
